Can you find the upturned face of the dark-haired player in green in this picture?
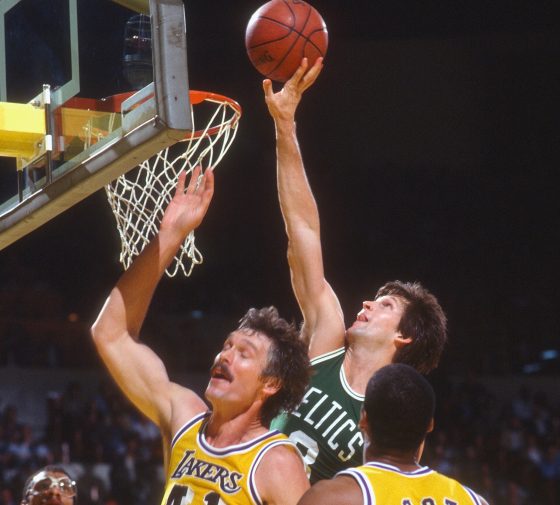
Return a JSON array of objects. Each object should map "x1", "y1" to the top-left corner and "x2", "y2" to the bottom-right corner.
[{"x1": 347, "y1": 295, "x2": 406, "y2": 342}]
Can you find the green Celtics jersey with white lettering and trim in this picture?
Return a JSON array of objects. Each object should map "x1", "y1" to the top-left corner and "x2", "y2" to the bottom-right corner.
[{"x1": 271, "y1": 348, "x2": 364, "y2": 484}]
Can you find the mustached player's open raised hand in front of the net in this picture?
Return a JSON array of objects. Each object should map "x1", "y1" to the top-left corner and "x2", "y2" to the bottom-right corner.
[{"x1": 160, "y1": 167, "x2": 214, "y2": 238}]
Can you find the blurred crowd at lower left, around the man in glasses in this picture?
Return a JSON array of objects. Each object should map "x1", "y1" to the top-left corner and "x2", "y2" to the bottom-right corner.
[{"x1": 0, "y1": 382, "x2": 164, "y2": 505}]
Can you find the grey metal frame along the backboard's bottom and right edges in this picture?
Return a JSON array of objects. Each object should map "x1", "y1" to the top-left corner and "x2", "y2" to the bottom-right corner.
[{"x1": 0, "y1": 0, "x2": 193, "y2": 250}]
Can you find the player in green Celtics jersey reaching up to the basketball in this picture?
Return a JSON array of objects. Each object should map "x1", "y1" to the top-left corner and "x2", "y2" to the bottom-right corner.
[{"x1": 263, "y1": 58, "x2": 446, "y2": 483}]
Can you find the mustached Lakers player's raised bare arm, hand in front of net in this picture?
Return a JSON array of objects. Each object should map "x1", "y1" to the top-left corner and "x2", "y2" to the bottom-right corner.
[{"x1": 91, "y1": 168, "x2": 214, "y2": 437}]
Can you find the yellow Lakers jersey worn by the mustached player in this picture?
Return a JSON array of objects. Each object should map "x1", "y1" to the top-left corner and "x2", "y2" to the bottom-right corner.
[{"x1": 162, "y1": 412, "x2": 303, "y2": 505}]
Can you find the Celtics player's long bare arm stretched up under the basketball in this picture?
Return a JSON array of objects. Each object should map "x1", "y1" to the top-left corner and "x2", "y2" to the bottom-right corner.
[{"x1": 263, "y1": 58, "x2": 345, "y2": 357}]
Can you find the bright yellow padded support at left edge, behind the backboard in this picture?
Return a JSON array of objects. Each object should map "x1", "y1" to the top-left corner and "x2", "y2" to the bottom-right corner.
[{"x1": 0, "y1": 102, "x2": 46, "y2": 158}]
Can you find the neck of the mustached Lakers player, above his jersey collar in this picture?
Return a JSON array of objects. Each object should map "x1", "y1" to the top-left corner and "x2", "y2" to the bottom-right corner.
[{"x1": 205, "y1": 409, "x2": 268, "y2": 447}]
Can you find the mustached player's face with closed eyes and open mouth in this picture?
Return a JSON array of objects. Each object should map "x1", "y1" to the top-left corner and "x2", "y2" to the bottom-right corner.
[{"x1": 206, "y1": 330, "x2": 271, "y2": 409}]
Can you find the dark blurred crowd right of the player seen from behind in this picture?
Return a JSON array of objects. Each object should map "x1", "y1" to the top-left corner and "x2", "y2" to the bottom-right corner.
[{"x1": 423, "y1": 377, "x2": 560, "y2": 505}]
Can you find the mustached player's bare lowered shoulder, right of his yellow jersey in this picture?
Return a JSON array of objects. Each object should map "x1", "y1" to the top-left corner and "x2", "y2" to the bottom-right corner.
[{"x1": 255, "y1": 445, "x2": 309, "y2": 505}]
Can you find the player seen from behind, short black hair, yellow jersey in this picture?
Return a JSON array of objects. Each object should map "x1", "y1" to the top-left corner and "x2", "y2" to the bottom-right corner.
[{"x1": 299, "y1": 363, "x2": 488, "y2": 505}]
